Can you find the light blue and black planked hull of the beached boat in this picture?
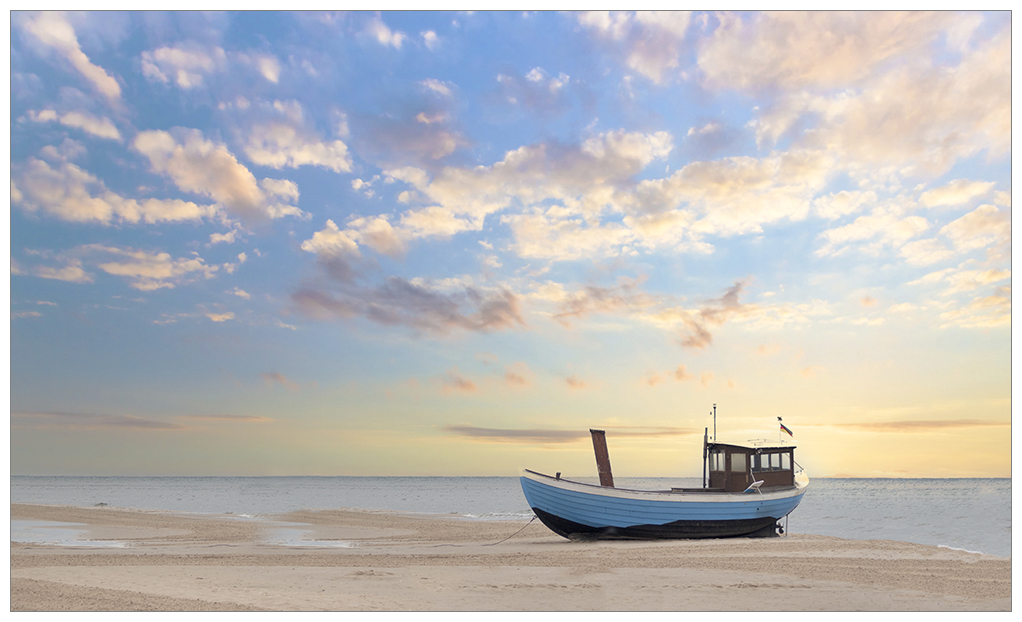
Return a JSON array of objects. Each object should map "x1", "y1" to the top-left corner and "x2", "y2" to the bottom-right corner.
[{"x1": 521, "y1": 471, "x2": 807, "y2": 539}]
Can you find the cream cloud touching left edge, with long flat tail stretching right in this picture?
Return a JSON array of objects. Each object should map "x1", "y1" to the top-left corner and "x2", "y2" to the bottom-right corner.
[{"x1": 11, "y1": 157, "x2": 219, "y2": 225}]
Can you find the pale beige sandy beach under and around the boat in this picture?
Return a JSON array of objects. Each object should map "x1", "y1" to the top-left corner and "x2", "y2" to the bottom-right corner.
[{"x1": 10, "y1": 504, "x2": 1012, "y2": 611}]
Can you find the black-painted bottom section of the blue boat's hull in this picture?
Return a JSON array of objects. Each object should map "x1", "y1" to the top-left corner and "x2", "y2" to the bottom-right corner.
[{"x1": 532, "y1": 508, "x2": 777, "y2": 540}]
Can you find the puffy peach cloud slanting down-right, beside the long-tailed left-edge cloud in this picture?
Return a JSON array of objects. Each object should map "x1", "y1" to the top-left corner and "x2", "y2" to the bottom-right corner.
[{"x1": 132, "y1": 128, "x2": 304, "y2": 220}]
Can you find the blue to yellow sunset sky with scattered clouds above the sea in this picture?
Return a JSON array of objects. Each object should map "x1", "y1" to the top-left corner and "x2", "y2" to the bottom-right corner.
[{"x1": 9, "y1": 11, "x2": 1012, "y2": 478}]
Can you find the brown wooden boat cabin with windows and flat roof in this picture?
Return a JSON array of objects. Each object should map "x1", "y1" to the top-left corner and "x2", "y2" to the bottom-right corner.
[{"x1": 706, "y1": 442, "x2": 795, "y2": 492}]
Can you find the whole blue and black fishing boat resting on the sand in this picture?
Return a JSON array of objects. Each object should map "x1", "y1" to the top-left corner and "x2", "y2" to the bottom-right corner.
[{"x1": 521, "y1": 404, "x2": 808, "y2": 539}]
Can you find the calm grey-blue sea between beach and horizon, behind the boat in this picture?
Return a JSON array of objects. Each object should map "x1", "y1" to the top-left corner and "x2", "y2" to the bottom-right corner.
[{"x1": 10, "y1": 476, "x2": 1012, "y2": 557}]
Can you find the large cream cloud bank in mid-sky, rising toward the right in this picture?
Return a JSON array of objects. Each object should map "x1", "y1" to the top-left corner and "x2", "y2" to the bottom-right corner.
[{"x1": 386, "y1": 131, "x2": 672, "y2": 258}]
